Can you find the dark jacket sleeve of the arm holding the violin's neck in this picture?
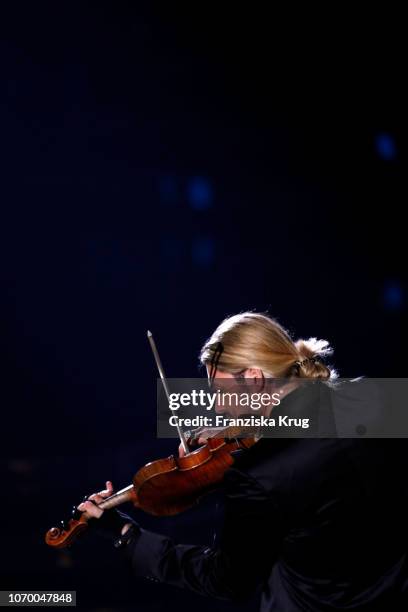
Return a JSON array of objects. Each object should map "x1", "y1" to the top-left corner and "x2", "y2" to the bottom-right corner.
[{"x1": 125, "y1": 469, "x2": 283, "y2": 600}]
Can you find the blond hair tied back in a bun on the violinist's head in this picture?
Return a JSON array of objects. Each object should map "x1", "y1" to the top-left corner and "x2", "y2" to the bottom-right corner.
[{"x1": 200, "y1": 312, "x2": 337, "y2": 380}]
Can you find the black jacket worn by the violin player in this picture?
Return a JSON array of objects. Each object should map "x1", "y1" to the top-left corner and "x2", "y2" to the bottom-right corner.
[{"x1": 115, "y1": 380, "x2": 408, "y2": 612}]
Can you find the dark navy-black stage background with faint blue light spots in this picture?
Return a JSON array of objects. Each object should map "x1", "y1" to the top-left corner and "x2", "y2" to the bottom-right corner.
[{"x1": 0, "y1": 1, "x2": 407, "y2": 611}]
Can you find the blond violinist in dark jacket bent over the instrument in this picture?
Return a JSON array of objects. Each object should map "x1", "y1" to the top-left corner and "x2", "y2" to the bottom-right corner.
[{"x1": 78, "y1": 312, "x2": 408, "y2": 612}]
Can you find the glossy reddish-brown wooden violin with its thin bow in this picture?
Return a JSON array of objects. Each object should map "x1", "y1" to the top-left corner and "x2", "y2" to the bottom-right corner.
[{"x1": 45, "y1": 332, "x2": 257, "y2": 548}]
